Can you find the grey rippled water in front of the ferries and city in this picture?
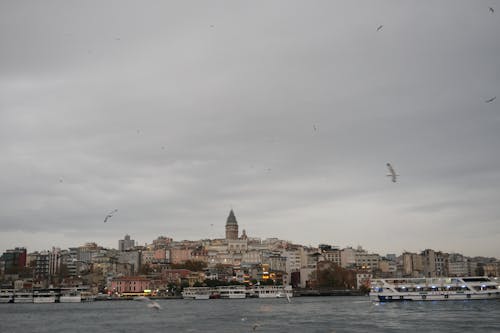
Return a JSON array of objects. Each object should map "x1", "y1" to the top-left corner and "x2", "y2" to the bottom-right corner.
[{"x1": 0, "y1": 297, "x2": 500, "y2": 333}]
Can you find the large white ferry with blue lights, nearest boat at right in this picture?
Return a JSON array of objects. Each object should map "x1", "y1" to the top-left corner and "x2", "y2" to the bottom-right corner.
[{"x1": 370, "y1": 276, "x2": 500, "y2": 302}]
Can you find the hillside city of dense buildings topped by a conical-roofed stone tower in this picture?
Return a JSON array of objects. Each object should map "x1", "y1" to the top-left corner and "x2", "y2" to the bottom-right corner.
[{"x1": 0, "y1": 210, "x2": 500, "y2": 297}]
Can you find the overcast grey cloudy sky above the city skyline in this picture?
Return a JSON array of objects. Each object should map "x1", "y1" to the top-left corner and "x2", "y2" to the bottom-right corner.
[{"x1": 0, "y1": 0, "x2": 500, "y2": 258}]
